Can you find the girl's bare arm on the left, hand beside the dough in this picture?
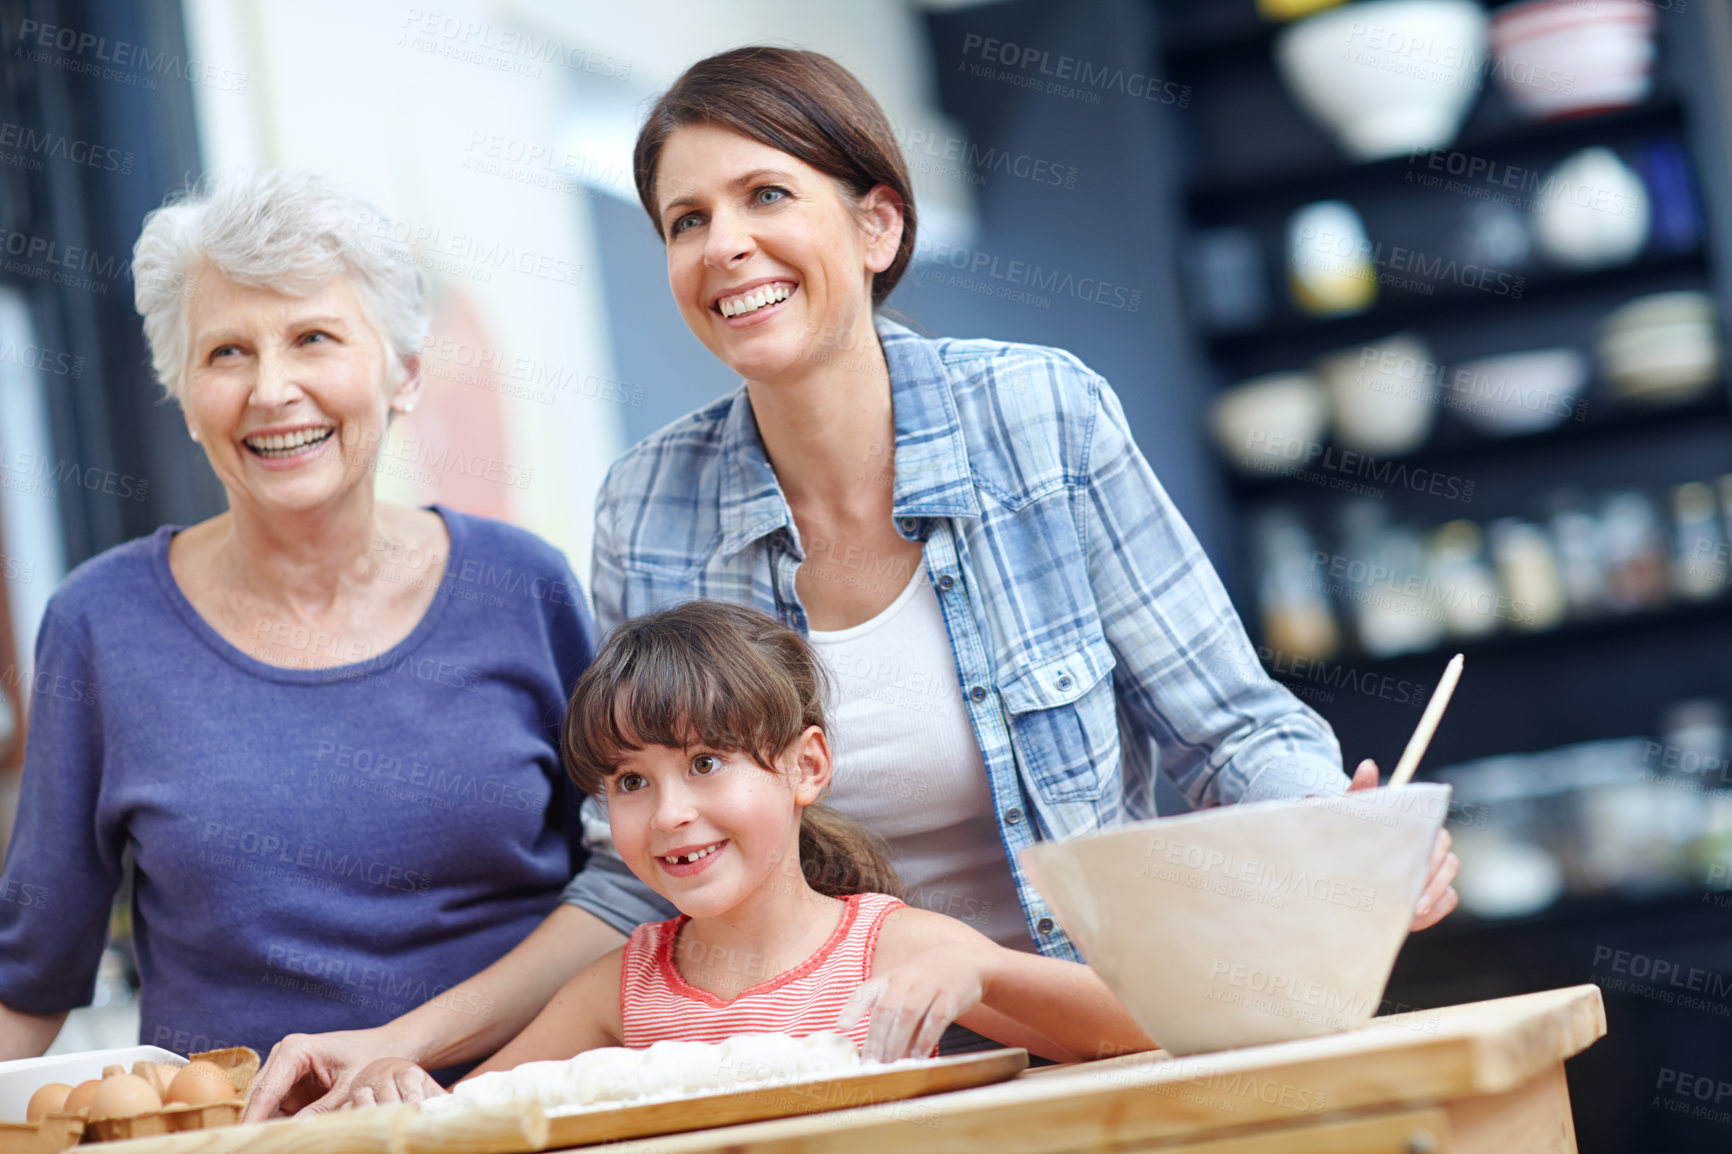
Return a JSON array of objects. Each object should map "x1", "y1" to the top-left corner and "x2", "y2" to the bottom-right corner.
[{"x1": 334, "y1": 946, "x2": 625, "y2": 1105}]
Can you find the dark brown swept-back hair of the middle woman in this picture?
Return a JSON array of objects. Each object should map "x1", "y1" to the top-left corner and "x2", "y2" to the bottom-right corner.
[{"x1": 632, "y1": 45, "x2": 914, "y2": 308}]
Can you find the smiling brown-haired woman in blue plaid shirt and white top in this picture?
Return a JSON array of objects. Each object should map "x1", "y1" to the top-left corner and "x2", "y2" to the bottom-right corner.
[{"x1": 249, "y1": 47, "x2": 1457, "y2": 1116}]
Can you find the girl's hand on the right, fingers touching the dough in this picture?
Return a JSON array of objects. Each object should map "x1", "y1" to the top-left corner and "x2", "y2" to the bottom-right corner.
[{"x1": 837, "y1": 943, "x2": 996, "y2": 1062}]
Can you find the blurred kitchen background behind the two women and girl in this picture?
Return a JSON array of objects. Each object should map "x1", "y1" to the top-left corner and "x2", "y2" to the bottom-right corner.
[{"x1": 0, "y1": 0, "x2": 1732, "y2": 1151}]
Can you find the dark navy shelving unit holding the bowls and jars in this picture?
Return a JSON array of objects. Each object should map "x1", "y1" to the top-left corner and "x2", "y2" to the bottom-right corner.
[{"x1": 1150, "y1": 0, "x2": 1732, "y2": 1151}]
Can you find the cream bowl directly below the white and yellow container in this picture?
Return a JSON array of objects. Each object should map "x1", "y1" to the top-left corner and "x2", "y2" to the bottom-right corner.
[{"x1": 1316, "y1": 333, "x2": 1438, "y2": 457}]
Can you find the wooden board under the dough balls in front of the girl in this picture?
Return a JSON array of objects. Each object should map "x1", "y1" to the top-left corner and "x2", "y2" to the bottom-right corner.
[{"x1": 540, "y1": 1050, "x2": 1029, "y2": 1154}]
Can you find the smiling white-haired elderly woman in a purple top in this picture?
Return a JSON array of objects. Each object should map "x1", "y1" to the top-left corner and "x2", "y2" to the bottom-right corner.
[{"x1": 0, "y1": 173, "x2": 592, "y2": 1059}]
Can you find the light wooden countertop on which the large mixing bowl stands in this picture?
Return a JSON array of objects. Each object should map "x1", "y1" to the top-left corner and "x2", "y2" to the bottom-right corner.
[{"x1": 568, "y1": 986, "x2": 1606, "y2": 1154}]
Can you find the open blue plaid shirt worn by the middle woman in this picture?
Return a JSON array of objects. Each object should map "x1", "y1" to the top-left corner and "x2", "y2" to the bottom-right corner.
[{"x1": 566, "y1": 319, "x2": 1347, "y2": 958}]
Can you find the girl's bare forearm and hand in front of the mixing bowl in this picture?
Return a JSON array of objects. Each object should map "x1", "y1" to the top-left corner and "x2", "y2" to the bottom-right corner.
[{"x1": 840, "y1": 908, "x2": 1155, "y2": 1062}]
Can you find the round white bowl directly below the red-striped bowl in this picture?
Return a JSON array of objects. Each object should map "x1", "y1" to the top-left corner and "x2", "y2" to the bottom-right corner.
[{"x1": 1533, "y1": 146, "x2": 1651, "y2": 269}]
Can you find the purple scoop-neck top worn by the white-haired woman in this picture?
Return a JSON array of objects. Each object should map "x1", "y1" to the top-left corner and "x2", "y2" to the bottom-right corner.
[{"x1": 0, "y1": 506, "x2": 594, "y2": 1054}]
